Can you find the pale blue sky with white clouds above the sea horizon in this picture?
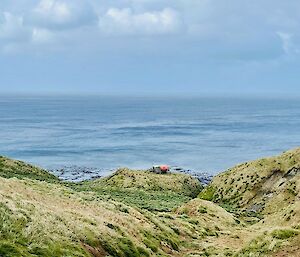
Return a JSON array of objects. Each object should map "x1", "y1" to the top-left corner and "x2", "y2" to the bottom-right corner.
[{"x1": 0, "y1": 0, "x2": 300, "y2": 95}]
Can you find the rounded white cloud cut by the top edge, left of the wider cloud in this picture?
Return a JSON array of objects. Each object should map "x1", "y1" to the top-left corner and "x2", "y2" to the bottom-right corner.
[{"x1": 26, "y1": 0, "x2": 97, "y2": 30}]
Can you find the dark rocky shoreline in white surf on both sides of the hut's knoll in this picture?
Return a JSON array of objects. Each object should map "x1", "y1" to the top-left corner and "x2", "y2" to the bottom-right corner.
[{"x1": 49, "y1": 165, "x2": 213, "y2": 186}]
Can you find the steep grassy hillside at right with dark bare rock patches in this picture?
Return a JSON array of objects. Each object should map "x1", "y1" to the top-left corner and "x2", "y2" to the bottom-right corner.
[{"x1": 200, "y1": 148, "x2": 300, "y2": 221}]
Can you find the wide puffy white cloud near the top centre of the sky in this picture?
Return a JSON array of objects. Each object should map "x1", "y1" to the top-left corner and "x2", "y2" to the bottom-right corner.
[{"x1": 99, "y1": 8, "x2": 183, "y2": 35}]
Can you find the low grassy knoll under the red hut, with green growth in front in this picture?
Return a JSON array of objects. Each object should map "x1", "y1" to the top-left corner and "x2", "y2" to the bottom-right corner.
[{"x1": 73, "y1": 169, "x2": 202, "y2": 212}]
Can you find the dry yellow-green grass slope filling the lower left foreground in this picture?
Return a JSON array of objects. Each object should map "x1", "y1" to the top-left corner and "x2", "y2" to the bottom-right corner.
[{"x1": 0, "y1": 176, "x2": 184, "y2": 257}]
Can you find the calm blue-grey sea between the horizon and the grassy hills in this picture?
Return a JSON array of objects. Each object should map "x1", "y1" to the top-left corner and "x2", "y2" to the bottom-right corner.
[{"x1": 0, "y1": 96, "x2": 300, "y2": 174}]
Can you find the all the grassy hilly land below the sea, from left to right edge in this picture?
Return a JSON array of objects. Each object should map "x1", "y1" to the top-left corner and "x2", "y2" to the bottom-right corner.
[{"x1": 0, "y1": 149, "x2": 300, "y2": 257}]
